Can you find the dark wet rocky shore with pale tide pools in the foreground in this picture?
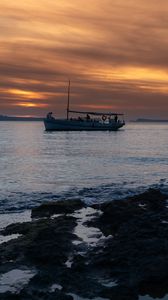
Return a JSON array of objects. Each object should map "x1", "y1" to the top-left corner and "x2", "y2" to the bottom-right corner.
[{"x1": 0, "y1": 190, "x2": 168, "y2": 300}]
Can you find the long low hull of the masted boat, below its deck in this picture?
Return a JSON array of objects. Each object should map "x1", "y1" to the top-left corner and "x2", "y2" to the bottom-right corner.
[{"x1": 44, "y1": 119, "x2": 125, "y2": 131}]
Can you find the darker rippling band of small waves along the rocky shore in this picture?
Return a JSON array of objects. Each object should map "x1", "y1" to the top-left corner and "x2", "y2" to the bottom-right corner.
[{"x1": 0, "y1": 178, "x2": 168, "y2": 214}]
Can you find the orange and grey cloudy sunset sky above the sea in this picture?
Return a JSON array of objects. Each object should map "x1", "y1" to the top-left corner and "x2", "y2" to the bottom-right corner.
[{"x1": 0, "y1": 0, "x2": 168, "y2": 119}]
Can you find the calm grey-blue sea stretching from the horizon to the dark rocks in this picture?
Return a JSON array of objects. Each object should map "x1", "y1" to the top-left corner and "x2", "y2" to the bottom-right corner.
[{"x1": 0, "y1": 122, "x2": 168, "y2": 213}]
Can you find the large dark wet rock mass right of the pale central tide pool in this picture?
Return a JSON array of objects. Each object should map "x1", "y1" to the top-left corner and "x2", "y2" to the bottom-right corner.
[{"x1": 92, "y1": 190, "x2": 168, "y2": 288}]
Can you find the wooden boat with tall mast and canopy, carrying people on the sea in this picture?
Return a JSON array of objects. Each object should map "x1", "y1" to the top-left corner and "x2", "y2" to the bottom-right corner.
[{"x1": 44, "y1": 81, "x2": 125, "y2": 131}]
